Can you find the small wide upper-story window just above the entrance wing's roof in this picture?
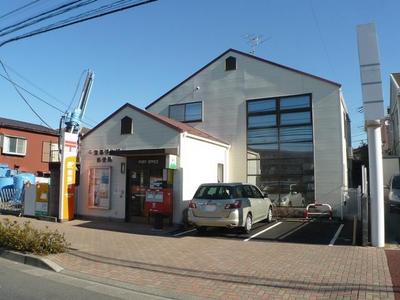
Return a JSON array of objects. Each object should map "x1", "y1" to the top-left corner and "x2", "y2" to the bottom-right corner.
[{"x1": 169, "y1": 101, "x2": 203, "y2": 122}]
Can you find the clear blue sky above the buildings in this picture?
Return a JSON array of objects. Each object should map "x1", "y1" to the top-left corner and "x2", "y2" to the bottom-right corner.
[{"x1": 0, "y1": 0, "x2": 400, "y2": 145}]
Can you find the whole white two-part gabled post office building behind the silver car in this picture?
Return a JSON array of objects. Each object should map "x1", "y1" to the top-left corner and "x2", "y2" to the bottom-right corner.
[{"x1": 78, "y1": 49, "x2": 352, "y2": 222}]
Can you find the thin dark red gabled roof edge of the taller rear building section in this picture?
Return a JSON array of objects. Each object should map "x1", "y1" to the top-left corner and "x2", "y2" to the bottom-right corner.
[{"x1": 146, "y1": 48, "x2": 341, "y2": 109}]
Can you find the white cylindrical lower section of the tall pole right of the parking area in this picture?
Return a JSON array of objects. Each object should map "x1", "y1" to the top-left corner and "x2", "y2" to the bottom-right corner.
[{"x1": 365, "y1": 120, "x2": 385, "y2": 247}]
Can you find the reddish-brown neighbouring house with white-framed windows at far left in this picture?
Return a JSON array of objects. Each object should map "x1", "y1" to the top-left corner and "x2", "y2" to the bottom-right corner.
[{"x1": 0, "y1": 118, "x2": 58, "y2": 176}]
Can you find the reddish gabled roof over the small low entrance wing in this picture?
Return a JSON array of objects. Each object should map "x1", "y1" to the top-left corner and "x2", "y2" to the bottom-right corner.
[{"x1": 82, "y1": 103, "x2": 229, "y2": 145}]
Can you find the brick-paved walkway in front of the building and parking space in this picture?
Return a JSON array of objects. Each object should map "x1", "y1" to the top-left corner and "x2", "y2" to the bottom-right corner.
[{"x1": 0, "y1": 216, "x2": 394, "y2": 299}]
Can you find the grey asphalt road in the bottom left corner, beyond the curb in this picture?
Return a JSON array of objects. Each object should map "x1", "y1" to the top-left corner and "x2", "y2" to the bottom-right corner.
[{"x1": 0, "y1": 258, "x2": 167, "y2": 300}]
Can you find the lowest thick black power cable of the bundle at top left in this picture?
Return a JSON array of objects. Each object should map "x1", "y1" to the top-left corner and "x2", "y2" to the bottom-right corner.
[{"x1": 0, "y1": 0, "x2": 158, "y2": 47}]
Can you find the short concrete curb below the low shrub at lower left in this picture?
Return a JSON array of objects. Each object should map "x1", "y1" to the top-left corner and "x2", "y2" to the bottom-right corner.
[{"x1": 0, "y1": 249, "x2": 64, "y2": 273}]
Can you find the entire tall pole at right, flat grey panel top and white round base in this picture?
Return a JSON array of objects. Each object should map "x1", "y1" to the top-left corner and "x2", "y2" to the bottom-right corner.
[{"x1": 357, "y1": 23, "x2": 385, "y2": 247}]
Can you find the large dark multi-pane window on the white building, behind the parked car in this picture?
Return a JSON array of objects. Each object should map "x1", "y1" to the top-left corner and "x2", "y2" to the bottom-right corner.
[{"x1": 247, "y1": 95, "x2": 314, "y2": 207}]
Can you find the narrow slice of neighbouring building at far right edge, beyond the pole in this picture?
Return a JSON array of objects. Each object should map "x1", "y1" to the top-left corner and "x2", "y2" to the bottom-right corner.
[{"x1": 389, "y1": 73, "x2": 400, "y2": 156}]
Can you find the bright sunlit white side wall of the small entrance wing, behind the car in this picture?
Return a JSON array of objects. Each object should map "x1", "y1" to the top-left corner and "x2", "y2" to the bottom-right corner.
[{"x1": 174, "y1": 133, "x2": 228, "y2": 223}]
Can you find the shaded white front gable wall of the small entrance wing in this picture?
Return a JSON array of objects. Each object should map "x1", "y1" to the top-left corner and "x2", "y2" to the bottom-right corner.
[{"x1": 77, "y1": 108, "x2": 179, "y2": 219}]
